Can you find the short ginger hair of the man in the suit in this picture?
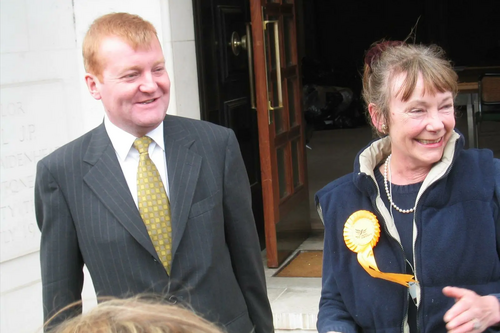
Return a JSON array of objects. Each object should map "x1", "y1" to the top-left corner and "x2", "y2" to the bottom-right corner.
[{"x1": 82, "y1": 13, "x2": 158, "y2": 78}]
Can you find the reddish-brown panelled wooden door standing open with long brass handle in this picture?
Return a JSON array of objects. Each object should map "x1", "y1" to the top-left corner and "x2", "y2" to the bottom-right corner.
[{"x1": 250, "y1": 0, "x2": 311, "y2": 267}]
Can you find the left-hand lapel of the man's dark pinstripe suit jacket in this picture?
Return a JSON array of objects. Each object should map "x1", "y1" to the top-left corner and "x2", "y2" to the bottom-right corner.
[{"x1": 84, "y1": 124, "x2": 158, "y2": 258}]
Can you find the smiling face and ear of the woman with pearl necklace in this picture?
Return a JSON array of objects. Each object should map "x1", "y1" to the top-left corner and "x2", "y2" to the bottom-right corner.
[{"x1": 376, "y1": 74, "x2": 455, "y2": 185}]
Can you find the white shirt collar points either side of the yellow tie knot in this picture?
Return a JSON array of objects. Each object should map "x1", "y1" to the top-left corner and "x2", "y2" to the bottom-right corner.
[{"x1": 104, "y1": 115, "x2": 165, "y2": 161}]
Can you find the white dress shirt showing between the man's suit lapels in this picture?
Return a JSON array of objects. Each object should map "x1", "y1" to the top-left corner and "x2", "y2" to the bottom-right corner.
[{"x1": 104, "y1": 116, "x2": 170, "y2": 206}]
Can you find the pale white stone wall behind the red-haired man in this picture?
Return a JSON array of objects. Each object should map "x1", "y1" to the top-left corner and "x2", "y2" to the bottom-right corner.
[{"x1": 0, "y1": 0, "x2": 200, "y2": 333}]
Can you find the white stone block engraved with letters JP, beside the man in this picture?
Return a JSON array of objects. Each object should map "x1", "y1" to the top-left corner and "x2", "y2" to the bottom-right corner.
[{"x1": 0, "y1": 80, "x2": 69, "y2": 262}]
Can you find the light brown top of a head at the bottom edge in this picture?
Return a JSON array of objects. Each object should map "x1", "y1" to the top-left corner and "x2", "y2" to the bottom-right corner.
[{"x1": 46, "y1": 297, "x2": 223, "y2": 333}]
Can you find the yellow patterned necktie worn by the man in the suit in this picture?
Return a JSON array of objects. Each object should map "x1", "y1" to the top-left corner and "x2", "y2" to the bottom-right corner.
[{"x1": 134, "y1": 136, "x2": 172, "y2": 275}]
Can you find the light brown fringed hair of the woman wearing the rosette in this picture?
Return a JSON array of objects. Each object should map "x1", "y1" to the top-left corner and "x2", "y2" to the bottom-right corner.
[{"x1": 363, "y1": 41, "x2": 458, "y2": 135}]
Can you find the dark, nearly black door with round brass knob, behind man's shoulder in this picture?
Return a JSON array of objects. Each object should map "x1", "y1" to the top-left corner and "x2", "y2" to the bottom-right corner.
[{"x1": 193, "y1": 0, "x2": 265, "y2": 249}]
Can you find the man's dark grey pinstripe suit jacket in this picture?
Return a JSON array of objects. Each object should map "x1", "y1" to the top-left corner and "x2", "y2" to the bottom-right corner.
[{"x1": 35, "y1": 116, "x2": 273, "y2": 333}]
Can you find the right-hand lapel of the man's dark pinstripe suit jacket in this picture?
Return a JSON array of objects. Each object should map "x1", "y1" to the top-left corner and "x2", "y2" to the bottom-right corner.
[{"x1": 164, "y1": 116, "x2": 202, "y2": 258}]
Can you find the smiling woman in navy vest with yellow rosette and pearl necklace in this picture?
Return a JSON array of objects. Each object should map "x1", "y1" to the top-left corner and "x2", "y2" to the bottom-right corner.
[{"x1": 316, "y1": 41, "x2": 500, "y2": 333}]
